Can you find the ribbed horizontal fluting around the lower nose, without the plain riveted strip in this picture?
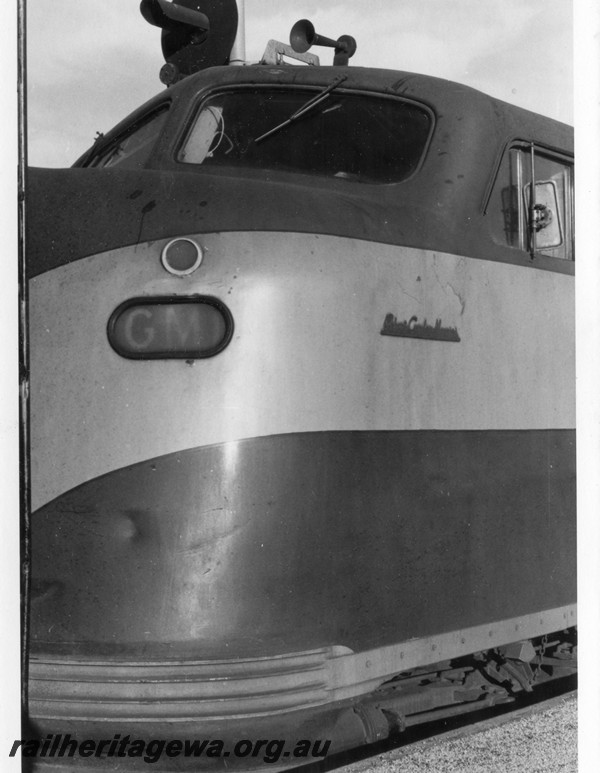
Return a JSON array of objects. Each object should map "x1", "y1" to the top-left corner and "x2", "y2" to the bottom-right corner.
[{"x1": 29, "y1": 647, "x2": 351, "y2": 721}]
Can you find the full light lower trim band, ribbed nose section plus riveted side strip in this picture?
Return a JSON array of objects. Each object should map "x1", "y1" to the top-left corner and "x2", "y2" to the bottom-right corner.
[{"x1": 29, "y1": 605, "x2": 576, "y2": 722}]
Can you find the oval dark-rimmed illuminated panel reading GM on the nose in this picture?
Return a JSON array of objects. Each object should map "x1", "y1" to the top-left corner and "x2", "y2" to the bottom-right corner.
[{"x1": 108, "y1": 296, "x2": 233, "y2": 360}]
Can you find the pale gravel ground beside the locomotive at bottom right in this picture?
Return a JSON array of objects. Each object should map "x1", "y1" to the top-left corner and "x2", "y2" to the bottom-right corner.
[{"x1": 290, "y1": 677, "x2": 577, "y2": 773}]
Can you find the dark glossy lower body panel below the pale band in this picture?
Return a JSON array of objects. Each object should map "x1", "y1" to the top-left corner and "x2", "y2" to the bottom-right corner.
[{"x1": 32, "y1": 431, "x2": 575, "y2": 659}]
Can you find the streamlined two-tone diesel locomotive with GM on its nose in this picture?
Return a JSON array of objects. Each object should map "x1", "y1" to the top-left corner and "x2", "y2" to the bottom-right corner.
[{"x1": 25, "y1": 0, "x2": 576, "y2": 770}]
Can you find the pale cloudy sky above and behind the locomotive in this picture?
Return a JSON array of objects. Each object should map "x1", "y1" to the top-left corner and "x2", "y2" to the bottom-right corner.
[{"x1": 26, "y1": 0, "x2": 573, "y2": 167}]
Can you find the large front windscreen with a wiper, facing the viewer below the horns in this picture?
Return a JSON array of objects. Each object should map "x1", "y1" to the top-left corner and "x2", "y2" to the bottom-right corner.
[{"x1": 178, "y1": 88, "x2": 432, "y2": 183}]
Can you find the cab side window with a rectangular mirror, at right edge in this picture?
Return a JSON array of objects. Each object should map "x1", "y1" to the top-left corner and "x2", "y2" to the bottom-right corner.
[{"x1": 486, "y1": 144, "x2": 574, "y2": 260}]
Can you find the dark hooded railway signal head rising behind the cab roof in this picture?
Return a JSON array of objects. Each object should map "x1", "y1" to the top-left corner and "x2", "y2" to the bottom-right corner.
[{"x1": 140, "y1": 0, "x2": 238, "y2": 86}]
